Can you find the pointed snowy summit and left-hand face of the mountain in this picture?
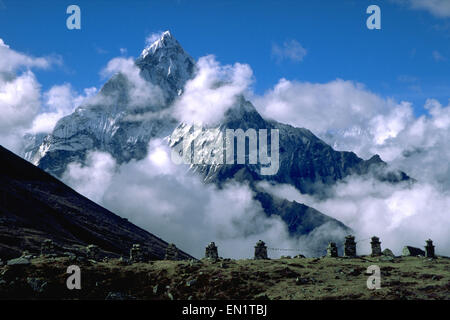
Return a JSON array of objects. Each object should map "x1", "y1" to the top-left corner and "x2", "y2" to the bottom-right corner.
[{"x1": 24, "y1": 32, "x2": 195, "y2": 177}]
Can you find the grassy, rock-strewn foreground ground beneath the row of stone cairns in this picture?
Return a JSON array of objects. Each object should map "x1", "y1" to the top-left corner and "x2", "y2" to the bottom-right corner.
[{"x1": 0, "y1": 252, "x2": 450, "y2": 300}]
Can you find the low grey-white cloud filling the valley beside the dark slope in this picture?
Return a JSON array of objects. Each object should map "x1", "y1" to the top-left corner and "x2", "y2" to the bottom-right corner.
[{"x1": 63, "y1": 139, "x2": 334, "y2": 258}]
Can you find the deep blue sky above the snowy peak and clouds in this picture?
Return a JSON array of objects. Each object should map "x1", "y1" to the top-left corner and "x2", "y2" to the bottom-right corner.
[{"x1": 0, "y1": 0, "x2": 450, "y2": 114}]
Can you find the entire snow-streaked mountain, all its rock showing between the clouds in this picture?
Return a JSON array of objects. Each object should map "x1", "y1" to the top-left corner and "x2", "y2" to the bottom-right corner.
[{"x1": 24, "y1": 31, "x2": 410, "y2": 253}]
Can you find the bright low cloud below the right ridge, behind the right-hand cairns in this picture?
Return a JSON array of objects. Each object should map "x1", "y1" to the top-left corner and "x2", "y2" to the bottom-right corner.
[{"x1": 263, "y1": 177, "x2": 450, "y2": 256}]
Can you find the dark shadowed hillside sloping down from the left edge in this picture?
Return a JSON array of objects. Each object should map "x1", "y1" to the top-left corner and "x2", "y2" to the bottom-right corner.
[{"x1": 0, "y1": 147, "x2": 192, "y2": 260}]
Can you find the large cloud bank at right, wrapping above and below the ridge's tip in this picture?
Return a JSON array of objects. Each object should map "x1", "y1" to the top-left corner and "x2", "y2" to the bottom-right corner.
[{"x1": 254, "y1": 80, "x2": 450, "y2": 255}]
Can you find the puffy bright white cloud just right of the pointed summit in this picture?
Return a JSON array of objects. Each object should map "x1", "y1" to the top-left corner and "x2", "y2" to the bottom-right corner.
[{"x1": 174, "y1": 55, "x2": 253, "y2": 125}]
